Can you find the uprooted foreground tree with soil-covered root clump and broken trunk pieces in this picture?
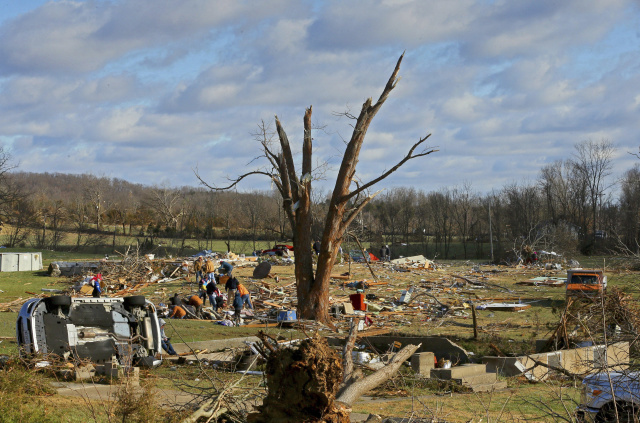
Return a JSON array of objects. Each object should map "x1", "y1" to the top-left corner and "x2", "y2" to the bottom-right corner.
[{"x1": 248, "y1": 330, "x2": 420, "y2": 423}]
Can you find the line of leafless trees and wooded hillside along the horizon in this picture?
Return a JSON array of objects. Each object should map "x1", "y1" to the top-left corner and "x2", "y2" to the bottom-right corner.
[{"x1": 0, "y1": 140, "x2": 640, "y2": 260}]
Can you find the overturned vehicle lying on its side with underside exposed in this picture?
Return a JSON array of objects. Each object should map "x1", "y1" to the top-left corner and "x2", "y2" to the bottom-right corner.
[{"x1": 16, "y1": 295, "x2": 162, "y2": 367}]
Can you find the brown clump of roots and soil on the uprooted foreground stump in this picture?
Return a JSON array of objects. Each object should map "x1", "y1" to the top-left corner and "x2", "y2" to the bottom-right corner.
[{"x1": 248, "y1": 336, "x2": 351, "y2": 423}]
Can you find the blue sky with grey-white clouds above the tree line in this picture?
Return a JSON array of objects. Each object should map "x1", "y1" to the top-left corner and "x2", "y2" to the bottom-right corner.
[{"x1": 0, "y1": 0, "x2": 640, "y2": 192}]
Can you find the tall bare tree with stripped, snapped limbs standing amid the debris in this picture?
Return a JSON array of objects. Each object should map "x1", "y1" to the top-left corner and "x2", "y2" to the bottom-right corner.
[{"x1": 196, "y1": 54, "x2": 437, "y2": 322}]
